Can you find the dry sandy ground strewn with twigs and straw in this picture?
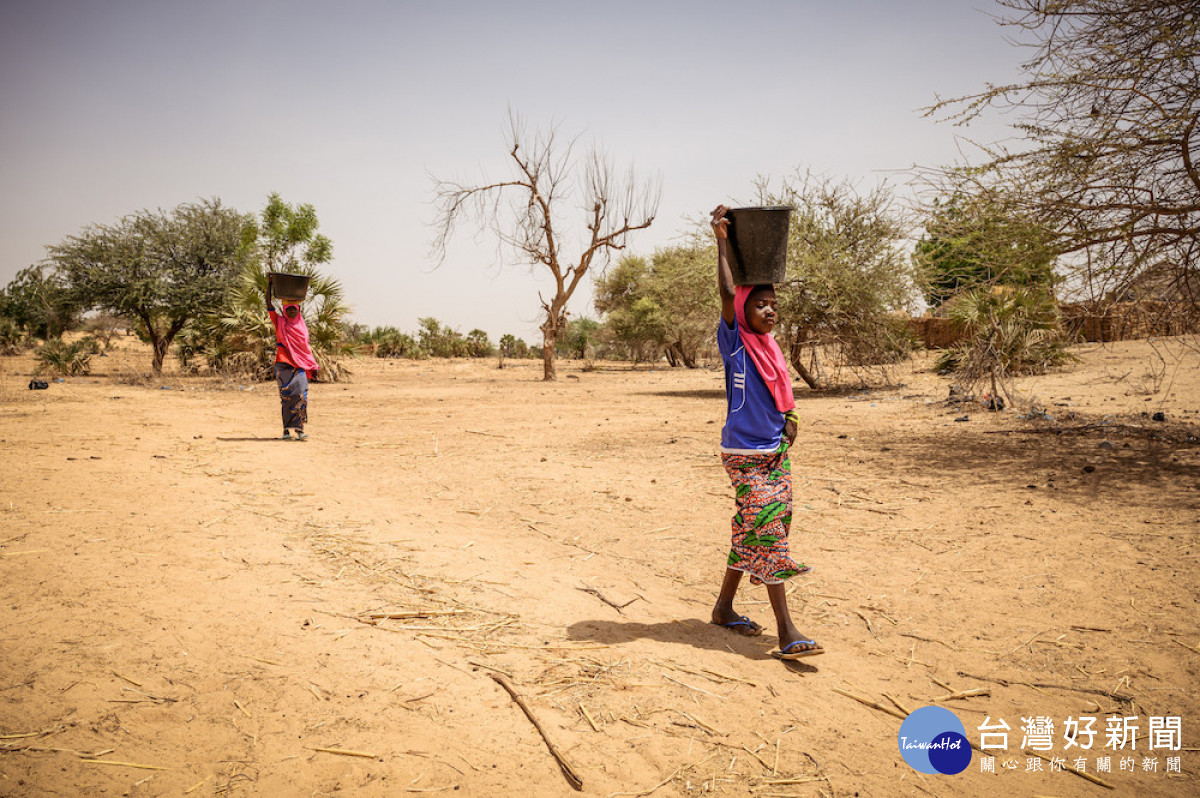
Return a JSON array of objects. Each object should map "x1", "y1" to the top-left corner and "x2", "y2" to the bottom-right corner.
[{"x1": 0, "y1": 341, "x2": 1200, "y2": 797}]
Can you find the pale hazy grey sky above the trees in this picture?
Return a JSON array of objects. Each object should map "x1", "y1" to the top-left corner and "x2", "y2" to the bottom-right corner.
[{"x1": 0, "y1": 0, "x2": 1026, "y2": 341}]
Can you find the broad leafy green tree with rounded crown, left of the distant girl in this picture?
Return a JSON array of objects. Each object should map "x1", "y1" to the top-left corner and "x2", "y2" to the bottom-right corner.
[{"x1": 49, "y1": 199, "x2": 253, "y2": 374}]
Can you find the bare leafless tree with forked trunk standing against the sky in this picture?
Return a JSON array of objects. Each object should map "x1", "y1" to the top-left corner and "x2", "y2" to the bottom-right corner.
[{"x1": 433, "y1": 114, "x2": 659, "y2": 380}]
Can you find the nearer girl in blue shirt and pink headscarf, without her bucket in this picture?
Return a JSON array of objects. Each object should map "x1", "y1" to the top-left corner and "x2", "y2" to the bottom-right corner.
[{"x1": 713, "y1": 205, "x2": 824, "y2": 660}]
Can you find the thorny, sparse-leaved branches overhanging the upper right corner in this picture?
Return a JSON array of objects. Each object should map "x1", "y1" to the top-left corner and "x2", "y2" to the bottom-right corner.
[{"x1": 928, "y1": 0, "x2": 1200, "y2": 304}]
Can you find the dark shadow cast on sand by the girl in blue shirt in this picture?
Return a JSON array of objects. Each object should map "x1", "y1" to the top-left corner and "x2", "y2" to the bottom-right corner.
[{"x1": 566, "y1": 618, "x2": 817, "y2": 673}]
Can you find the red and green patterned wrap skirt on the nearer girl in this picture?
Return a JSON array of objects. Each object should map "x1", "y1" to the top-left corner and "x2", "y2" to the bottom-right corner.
[{"x1": 721, "y1": 440, "x2": 809, "y2": 584}]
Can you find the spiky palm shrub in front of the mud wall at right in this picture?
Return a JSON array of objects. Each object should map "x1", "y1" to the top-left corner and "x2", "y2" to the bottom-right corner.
[{"x1": 936, "y1": 286, "x2": 1073, "y2": 404}]
